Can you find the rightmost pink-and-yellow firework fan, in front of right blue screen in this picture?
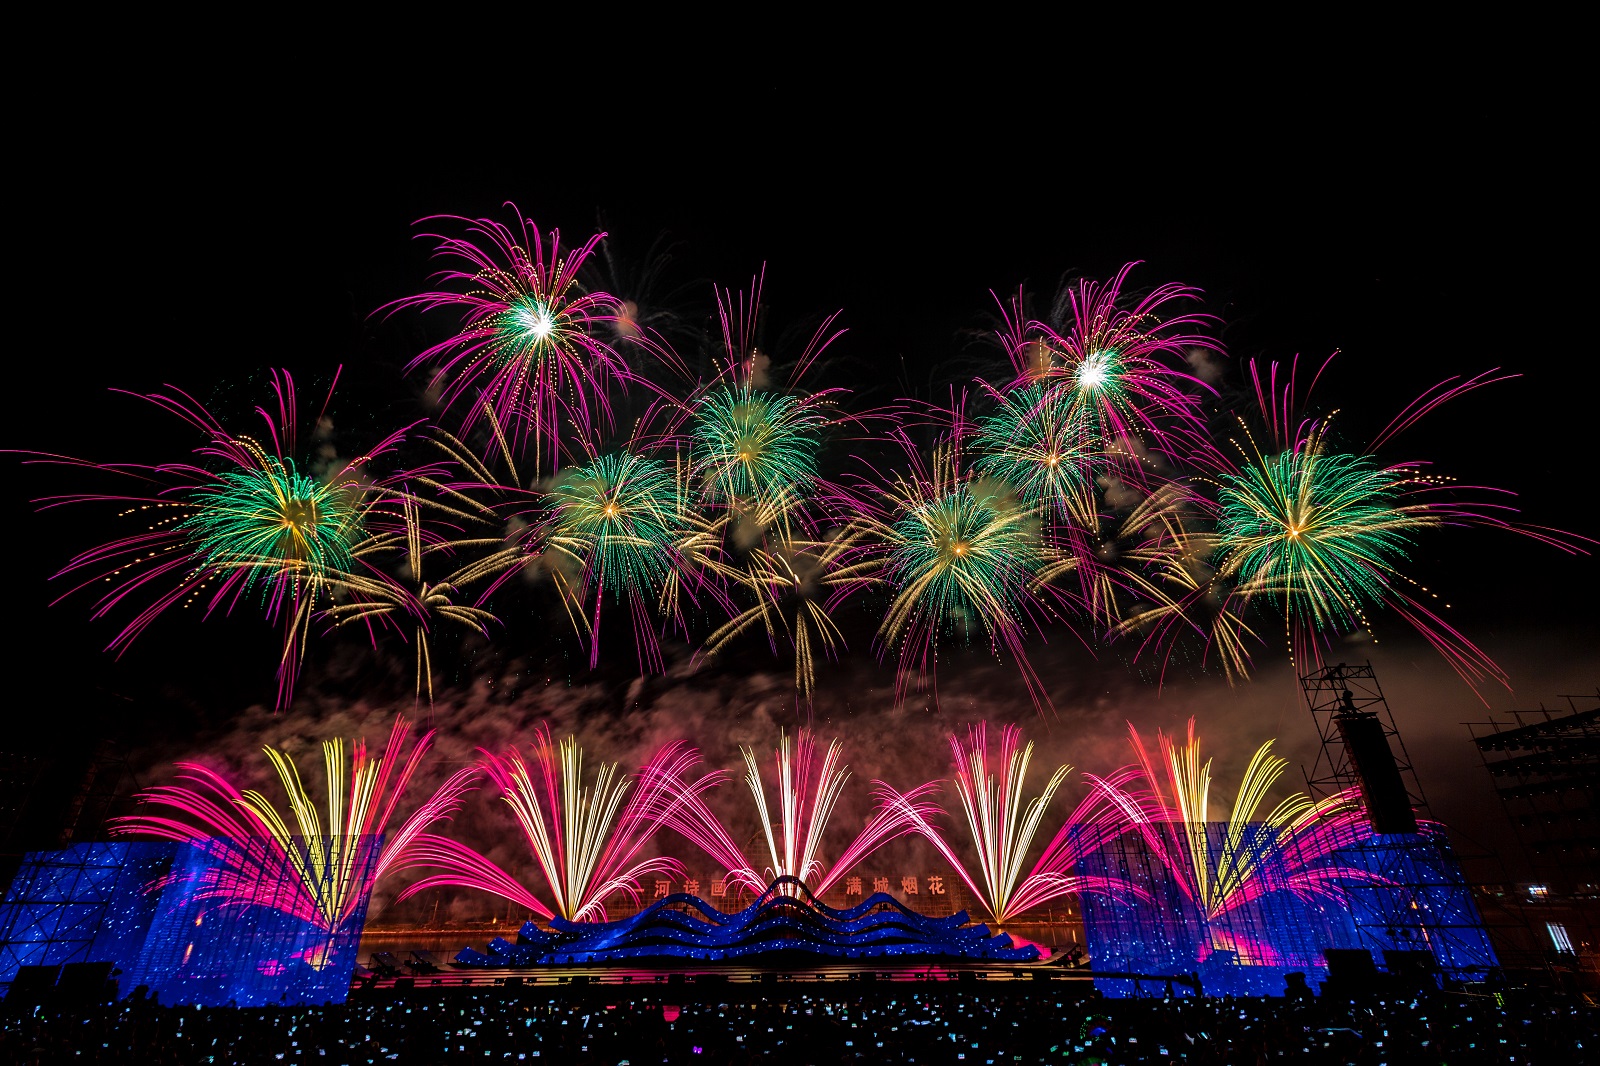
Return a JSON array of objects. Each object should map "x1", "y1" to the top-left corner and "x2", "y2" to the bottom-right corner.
[{"x1": 1085, "y1": 719, "x2": 1374, "y2": 920}]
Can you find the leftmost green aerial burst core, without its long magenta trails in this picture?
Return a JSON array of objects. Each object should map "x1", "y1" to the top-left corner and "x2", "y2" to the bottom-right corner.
[{"x1": 178, "y1": 459, "x2": 363, "y2": 587}]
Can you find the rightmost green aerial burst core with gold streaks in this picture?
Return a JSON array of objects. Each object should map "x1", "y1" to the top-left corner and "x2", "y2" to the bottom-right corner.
[{"x1": 1216, "y1": 434, "x2": 1438, "y2": 627}]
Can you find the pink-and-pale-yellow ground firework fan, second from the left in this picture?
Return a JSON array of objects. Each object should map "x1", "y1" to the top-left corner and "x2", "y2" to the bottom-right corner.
[{"x1": 400, "y1": 725, "x2": 725, "y2": 922}]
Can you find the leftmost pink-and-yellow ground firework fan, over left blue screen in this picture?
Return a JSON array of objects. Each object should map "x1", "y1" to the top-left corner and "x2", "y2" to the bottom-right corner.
[{"x1": 112, "y1": 717, "x2": 478, "y2": 932}]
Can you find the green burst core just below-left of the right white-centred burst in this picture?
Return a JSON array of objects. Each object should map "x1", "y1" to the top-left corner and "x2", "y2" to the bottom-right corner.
[{"x1": 973, "y1": 383, "x2": 1096, "y2": 520}]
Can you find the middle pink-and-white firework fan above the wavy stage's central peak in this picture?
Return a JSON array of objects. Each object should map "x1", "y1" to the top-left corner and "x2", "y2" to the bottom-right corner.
[{"x1": 666, "y1": 730, "x2": 934, "y2": 896}]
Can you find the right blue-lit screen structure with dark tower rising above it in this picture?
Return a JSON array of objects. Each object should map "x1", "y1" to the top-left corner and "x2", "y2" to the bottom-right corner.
[{"x1": 1078, "y1": 664, "x2": 1498, "y2": 996}]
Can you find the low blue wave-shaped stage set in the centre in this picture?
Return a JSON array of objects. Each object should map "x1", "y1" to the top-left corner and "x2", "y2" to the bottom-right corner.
[{"x1": 456, "y1": 877, "x2": 1038, "y2": 968}]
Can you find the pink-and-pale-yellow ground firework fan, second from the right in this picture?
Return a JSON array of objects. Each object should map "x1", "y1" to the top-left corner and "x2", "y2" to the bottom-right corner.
[{"x1": 888, "y1": 723, "x2": 1134, "y2": 925}]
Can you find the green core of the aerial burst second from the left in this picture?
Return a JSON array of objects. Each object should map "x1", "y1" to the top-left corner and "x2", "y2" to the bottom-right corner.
[{"x1": 550, "y1": 451, "x2": 683, "y2": 592}]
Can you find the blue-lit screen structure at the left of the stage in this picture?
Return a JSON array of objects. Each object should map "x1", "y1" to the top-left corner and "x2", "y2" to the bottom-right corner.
[{"x1": 0, "y1": 840, "x2": 378, "y2": 1007}]
